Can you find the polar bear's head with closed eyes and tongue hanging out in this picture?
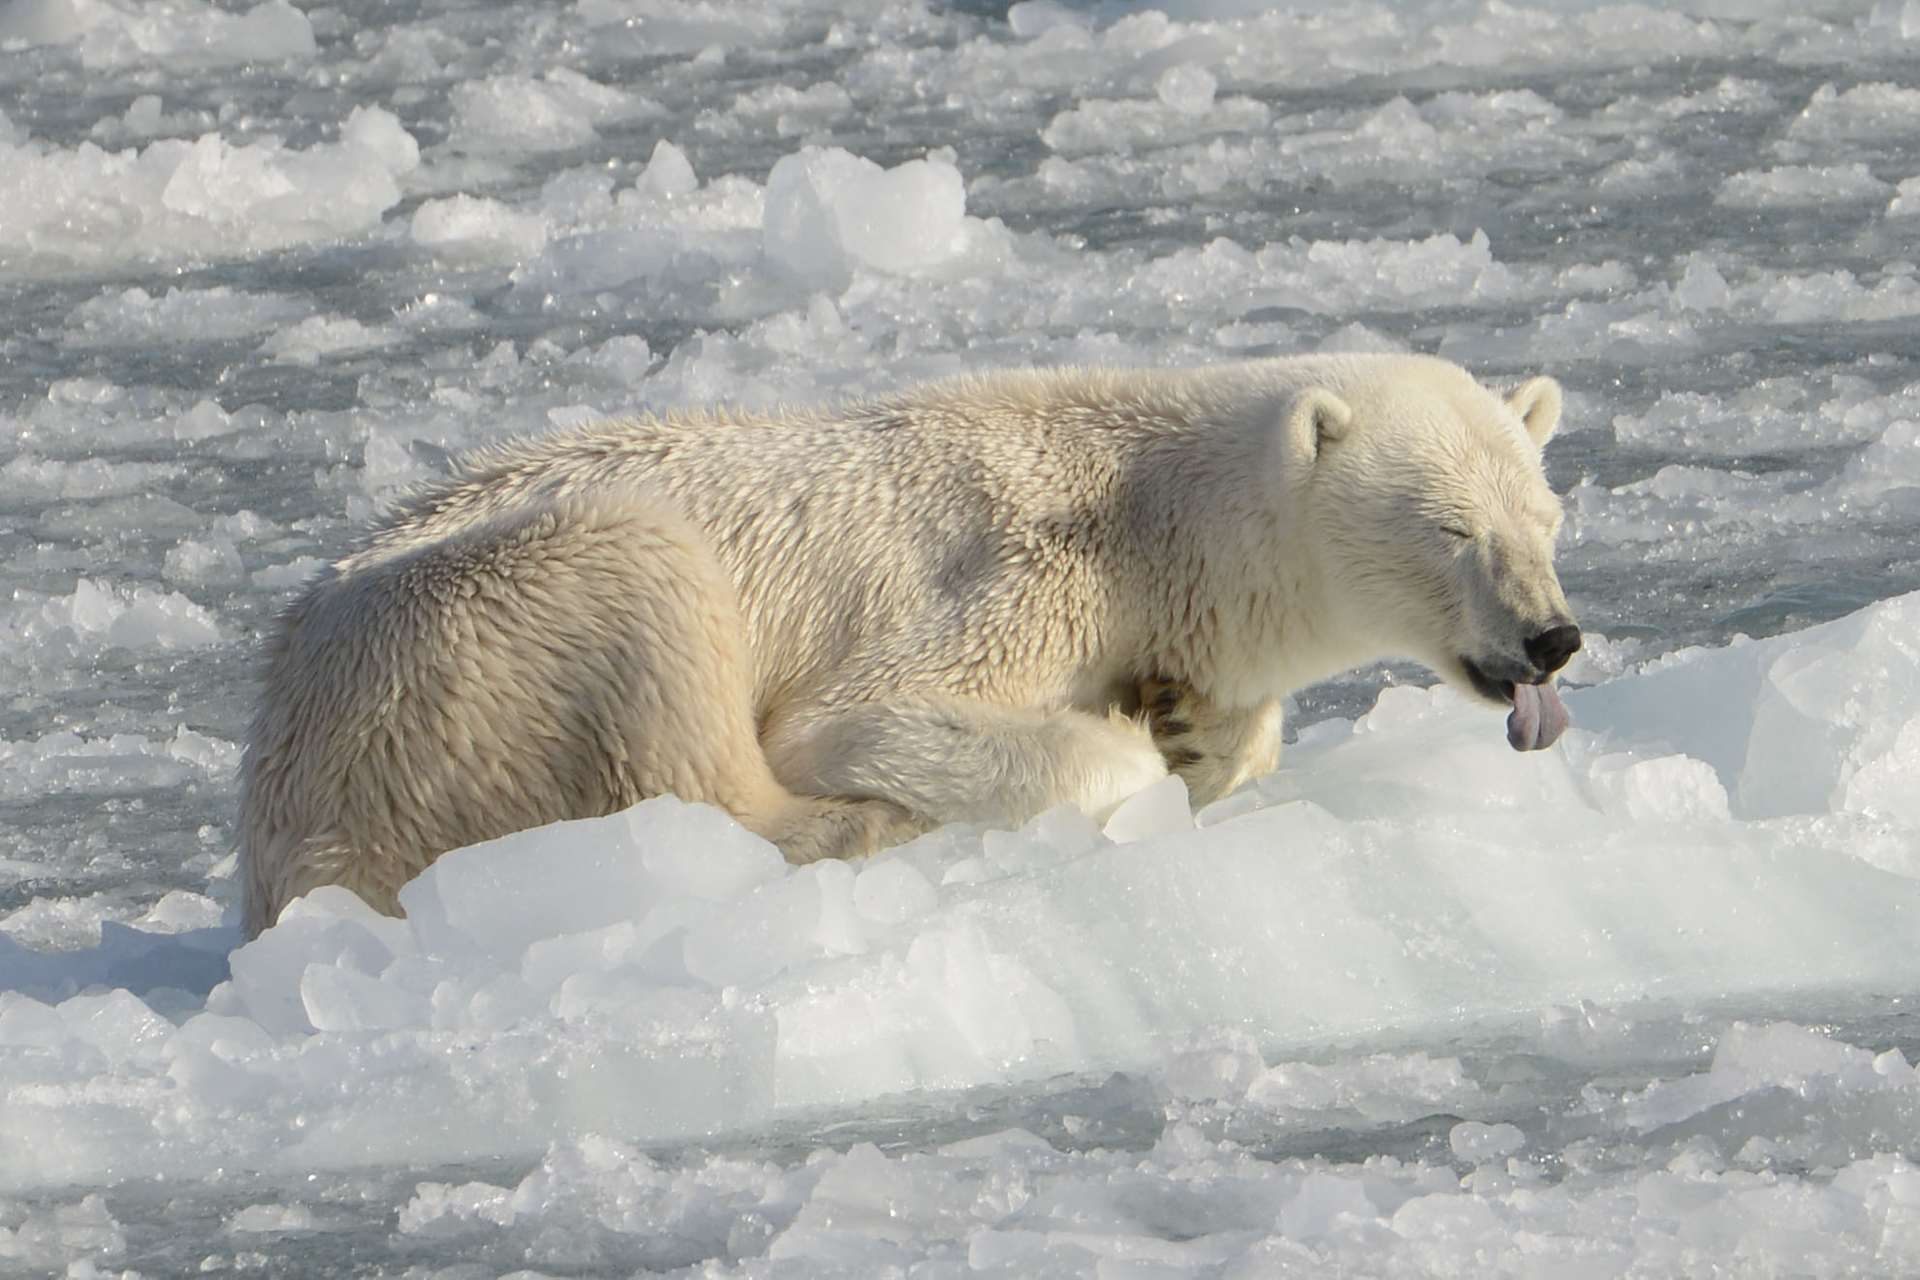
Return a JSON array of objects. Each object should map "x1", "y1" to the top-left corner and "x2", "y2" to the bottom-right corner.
[{"x1": 1284, "y1": 357, "x2": 1580, "y2": 750}]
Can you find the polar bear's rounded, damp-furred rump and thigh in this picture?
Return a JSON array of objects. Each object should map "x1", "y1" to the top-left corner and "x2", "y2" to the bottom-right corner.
[{"x1": 242, "y1": 495, "x2": 780, "y2": 929}]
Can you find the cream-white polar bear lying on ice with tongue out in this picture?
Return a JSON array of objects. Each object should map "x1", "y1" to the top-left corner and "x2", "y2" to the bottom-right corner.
[{"x1": 240, "y1": 355, "x2": 1580, "y2": 933}]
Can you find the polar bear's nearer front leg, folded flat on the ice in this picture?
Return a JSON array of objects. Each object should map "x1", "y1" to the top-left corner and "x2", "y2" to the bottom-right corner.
[{"x1": 762, "y1": 697, "x2": 1167, "y2": 825}]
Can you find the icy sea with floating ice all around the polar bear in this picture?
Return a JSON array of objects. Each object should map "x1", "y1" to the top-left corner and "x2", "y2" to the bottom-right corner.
[{"x1": 0, "y1": 0, "x2": 1920, "y2": 1276}]
